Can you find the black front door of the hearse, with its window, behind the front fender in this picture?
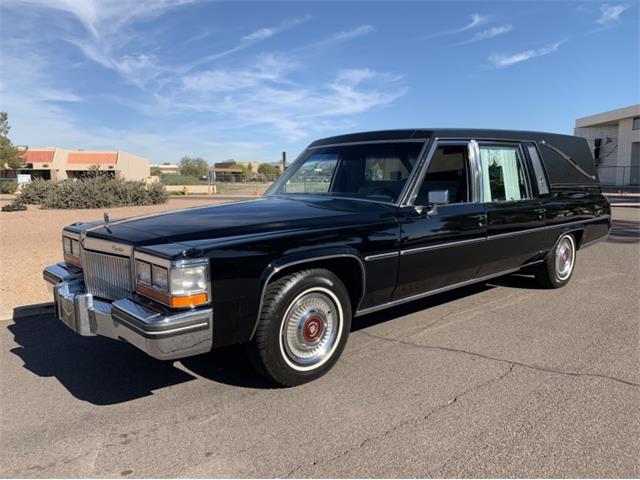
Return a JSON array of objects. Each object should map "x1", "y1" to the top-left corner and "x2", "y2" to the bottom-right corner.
[{"x1": 392, "y1": 141, "x2": 486, "y2": 300}]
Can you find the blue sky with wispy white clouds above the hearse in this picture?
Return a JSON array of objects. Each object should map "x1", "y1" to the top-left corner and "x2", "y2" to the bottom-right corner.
[{"x1": 0, "y1": 0, "x2": 640, "y2": 163}]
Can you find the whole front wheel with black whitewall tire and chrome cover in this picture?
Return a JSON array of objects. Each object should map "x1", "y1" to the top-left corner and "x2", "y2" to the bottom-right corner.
[{"x1": 249, "y1": 269, "x2": 351, "y2": 386}]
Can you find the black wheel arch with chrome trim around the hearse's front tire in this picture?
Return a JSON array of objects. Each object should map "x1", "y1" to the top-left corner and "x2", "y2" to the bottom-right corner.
[{"x1": 250, "y1": 248, "x2": 366, "y2": 339}]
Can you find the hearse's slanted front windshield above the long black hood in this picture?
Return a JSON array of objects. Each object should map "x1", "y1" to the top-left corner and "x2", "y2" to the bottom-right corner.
[{"x1": 266, "y1": 141, "x2": 423, "y2": 203}]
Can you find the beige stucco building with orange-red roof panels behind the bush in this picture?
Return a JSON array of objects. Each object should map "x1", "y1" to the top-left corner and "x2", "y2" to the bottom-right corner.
[{"x1": 9, "y1": 147, "x2": 149, "y2": 180}]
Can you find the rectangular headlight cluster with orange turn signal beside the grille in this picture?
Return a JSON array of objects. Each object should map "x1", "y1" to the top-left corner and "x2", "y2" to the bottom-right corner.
[{"x1": 135, "y1": 253, "x2": 210, "y2": 308}]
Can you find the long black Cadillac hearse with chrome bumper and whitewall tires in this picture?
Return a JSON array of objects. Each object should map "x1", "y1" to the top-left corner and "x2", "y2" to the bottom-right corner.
[{"x1": 44, "y1": 129, "x2": 611, "y2": 385}]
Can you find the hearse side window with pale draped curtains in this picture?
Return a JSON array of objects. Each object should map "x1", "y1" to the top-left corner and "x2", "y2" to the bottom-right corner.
[{"x1": 480, "y1": 145, "x2": 531, "y2": 203}]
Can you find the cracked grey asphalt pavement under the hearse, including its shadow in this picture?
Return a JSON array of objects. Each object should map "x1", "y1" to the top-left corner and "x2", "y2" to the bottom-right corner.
[{"x1": 0, "y1": 206, "x2": 640, "y2": 477}]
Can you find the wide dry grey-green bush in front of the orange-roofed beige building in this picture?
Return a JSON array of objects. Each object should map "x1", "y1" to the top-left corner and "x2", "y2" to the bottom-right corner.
[{"x1": 10, "y1": 174, "x2": 168, "y2": 209}]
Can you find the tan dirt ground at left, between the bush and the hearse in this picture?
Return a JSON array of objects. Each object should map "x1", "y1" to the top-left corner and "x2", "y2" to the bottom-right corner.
[{"x1": 0, "y1": 196, "x2": 242, "y2": 320}]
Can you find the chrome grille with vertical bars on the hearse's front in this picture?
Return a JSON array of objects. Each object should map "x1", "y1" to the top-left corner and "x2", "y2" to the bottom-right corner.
[{"x1": 82, "y1": 250, "x2": 133, "y2": 300}]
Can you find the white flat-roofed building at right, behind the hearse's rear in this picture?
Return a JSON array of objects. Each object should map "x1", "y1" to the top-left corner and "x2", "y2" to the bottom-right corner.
[{"x1": 574, "y1": 104, "x2": 640, "y2": 186}]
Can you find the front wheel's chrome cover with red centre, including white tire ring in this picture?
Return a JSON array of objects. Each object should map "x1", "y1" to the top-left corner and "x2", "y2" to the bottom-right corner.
[{"x1": 280, "y1": 287, "x2": 343, "y2": 371}]
